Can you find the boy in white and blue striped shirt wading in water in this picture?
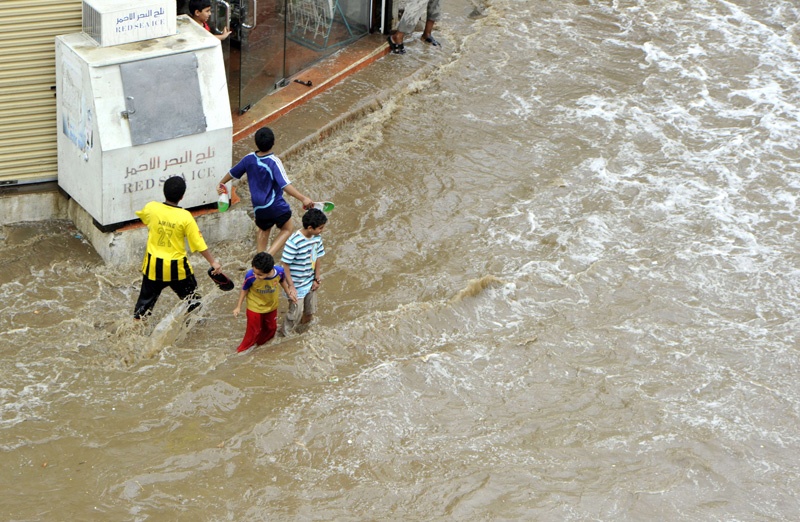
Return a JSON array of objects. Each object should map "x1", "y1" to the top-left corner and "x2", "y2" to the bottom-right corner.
[{"x1": 280, "y1": 208, "x2": 328, "y2": 336}]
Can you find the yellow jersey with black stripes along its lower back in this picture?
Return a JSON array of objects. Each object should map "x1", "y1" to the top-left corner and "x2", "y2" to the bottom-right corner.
[{"x1": 136, "y1": 201, "x2": 208, "y2": 281}]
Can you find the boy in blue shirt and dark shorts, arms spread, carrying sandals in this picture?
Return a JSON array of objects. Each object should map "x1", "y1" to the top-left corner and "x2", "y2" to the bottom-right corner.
[{"x1": 217, "y1": 127, "x2": 314, "y2": 257}]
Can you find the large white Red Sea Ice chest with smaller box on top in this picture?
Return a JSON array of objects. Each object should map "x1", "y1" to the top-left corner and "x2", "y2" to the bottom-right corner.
[{"x1": 56, "y1": 0, "x2": 233, "y2": 232}]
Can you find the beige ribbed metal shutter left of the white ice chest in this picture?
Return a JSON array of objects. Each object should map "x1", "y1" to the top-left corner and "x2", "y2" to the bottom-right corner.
[{"x1": 0, "y1": 0, "x2": 82, "y2": 186}]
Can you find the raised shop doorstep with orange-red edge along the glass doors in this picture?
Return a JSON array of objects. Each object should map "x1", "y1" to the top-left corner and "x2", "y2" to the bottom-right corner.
[{"x1": 233, "y1": 33, "x2": 389, "y2": 143}]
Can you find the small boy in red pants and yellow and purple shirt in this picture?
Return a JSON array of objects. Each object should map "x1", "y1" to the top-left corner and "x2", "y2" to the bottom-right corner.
[{"x1": 233, "y1": 252, "x2": 297, "y2": 352}]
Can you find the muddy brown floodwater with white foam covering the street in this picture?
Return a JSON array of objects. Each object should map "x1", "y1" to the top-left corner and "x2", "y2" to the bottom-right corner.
[{"x1": 0, "y1": 0, "x2": 800, "y2": 521}]
